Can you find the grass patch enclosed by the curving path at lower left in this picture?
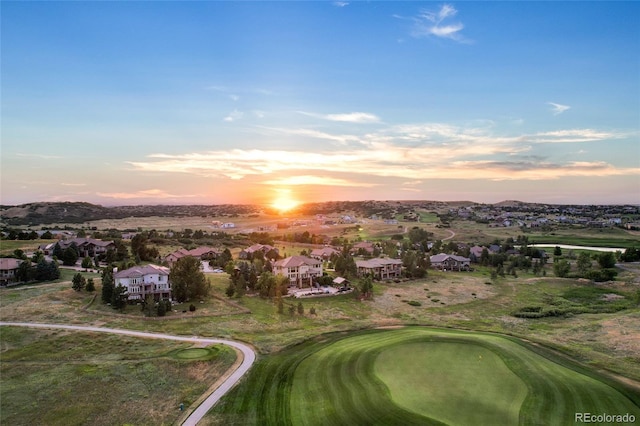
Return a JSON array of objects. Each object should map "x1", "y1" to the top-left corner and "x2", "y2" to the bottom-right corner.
[{"x1": 0, "y1": 327, "x2": 236, "y2": 426}]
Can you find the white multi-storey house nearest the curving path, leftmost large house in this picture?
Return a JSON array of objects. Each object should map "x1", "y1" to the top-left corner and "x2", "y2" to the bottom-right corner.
[{"x1": 113, "y1": 264, "x2": 171, "y2": 301}]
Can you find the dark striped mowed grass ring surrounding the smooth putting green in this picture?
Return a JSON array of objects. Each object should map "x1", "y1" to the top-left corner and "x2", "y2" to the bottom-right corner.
[{"x1": 215, "y1": 327, "x2": 640, "y2": 425}]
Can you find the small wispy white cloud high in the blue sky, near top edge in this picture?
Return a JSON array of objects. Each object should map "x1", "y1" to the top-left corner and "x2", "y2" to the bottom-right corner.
[{"x1": 411, "y1": 4, "x2": 470, "y2": 43}]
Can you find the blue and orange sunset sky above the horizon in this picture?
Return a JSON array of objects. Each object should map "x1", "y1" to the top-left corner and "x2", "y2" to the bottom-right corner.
[{"x1": 0, "y1": 1, "x2": 640, "y2": 206}]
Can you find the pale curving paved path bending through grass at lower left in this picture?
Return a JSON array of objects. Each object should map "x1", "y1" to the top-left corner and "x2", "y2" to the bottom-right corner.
[{"x1": 0, "y1": 321, "x2": 256, "y2": 426}]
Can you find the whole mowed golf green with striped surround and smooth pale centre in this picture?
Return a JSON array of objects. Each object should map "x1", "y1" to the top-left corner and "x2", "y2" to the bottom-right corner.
[{"x1": 213, "y1": 327, "x2": 640, "y2": 425}]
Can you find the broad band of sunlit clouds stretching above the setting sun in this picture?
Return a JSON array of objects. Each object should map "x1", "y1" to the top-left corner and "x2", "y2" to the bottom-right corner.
[{"x1": 128, "y1": 123, "x2": 640, "y2": 188}]
